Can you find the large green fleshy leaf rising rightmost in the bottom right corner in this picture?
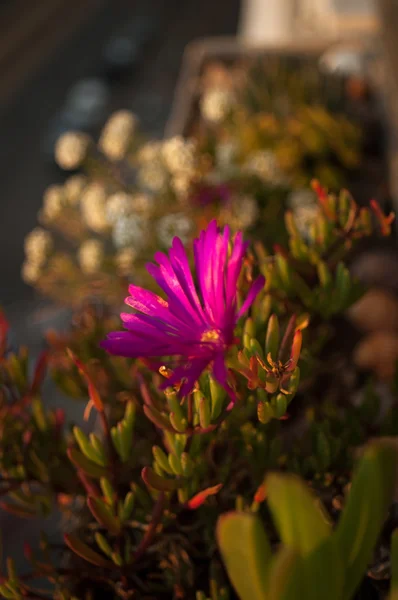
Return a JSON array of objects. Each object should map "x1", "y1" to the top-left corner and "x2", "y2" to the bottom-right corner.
[{"x1": 334, "y1": 438, "x2": 398, "y2": 600}]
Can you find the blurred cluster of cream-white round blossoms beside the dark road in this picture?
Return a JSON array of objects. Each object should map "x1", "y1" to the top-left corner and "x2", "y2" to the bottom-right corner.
[{"x1": 22, "y1": 110, "x2": 205, "y2": 305}]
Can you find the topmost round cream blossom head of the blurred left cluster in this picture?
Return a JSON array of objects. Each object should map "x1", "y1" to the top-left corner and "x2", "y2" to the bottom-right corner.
[{"x1": 98, "y1": 110, "x2": 137, "y2": 160}]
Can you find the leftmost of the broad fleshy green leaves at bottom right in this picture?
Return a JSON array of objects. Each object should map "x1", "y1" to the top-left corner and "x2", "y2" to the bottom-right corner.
[{"x1": 217, "y1": 512, "x2": 271, "y2": 600}]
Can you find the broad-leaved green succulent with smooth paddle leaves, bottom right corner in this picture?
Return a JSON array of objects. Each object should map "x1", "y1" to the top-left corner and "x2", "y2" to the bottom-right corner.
[{"x1": 217, "y1": 438, "x2": 397, "y2": 600}]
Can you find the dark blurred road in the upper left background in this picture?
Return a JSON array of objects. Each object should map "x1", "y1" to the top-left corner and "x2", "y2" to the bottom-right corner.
[{"x1": 0, "y1": 0, "x2": 239, "y2": 338}]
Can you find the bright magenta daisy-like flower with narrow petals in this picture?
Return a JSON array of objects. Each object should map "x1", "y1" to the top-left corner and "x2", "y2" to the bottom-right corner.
[{"x1": 101, "y1": 221, "x2": 264, "y2": 397}]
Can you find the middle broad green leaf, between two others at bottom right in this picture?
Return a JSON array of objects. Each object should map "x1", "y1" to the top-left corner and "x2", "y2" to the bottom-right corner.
[{"x1": 266, "y1": 474, "x2": 331, "y2": 556}]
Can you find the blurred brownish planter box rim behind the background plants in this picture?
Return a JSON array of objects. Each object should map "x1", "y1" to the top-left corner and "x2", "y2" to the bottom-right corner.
[{"x1": 165, "y1": 37, "x2": 398, "y2": 218}]
